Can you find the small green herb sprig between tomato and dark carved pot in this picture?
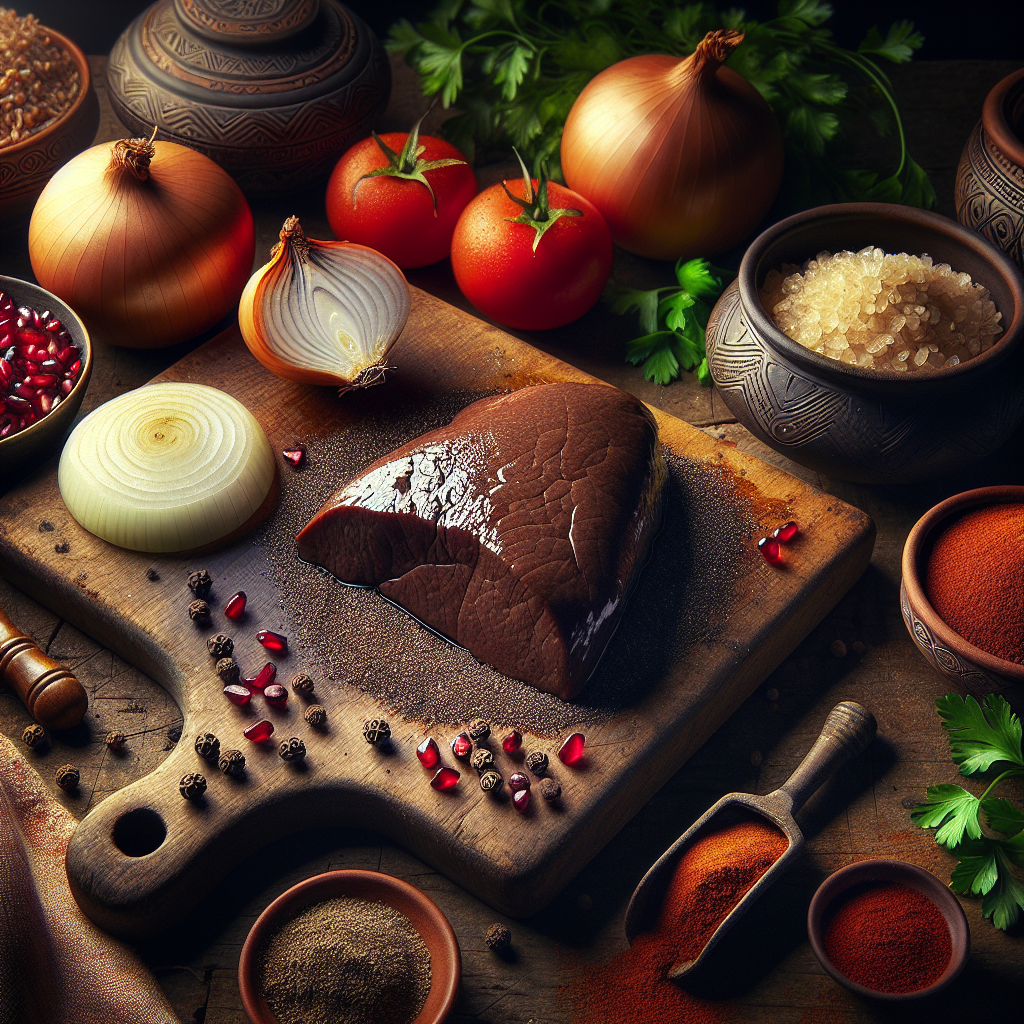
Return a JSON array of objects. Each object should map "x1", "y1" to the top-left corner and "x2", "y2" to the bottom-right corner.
[{"x1": 604, "y1": 259, "x2": 729, "y2": 385}]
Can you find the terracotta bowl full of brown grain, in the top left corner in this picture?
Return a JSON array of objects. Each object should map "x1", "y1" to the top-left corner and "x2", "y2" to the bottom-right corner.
[{"x1": 0, "y1": 8, "x2": 99, "y2": 230}]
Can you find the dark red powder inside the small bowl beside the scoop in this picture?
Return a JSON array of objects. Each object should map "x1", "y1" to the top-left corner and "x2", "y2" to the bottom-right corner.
[{"x1": 824, "y1": 883, "x2": 952, "y2": 993}]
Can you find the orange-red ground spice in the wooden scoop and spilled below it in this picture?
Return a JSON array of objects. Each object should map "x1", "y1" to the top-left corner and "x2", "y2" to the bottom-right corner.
[{"x1": 562, "y1": 821, "x2": 788, "y2": 1024}]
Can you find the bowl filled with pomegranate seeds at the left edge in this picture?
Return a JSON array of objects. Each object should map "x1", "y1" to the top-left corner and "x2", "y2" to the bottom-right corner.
[{"x1": 0, "y1": 276, "x2": 92, "y2": 472}]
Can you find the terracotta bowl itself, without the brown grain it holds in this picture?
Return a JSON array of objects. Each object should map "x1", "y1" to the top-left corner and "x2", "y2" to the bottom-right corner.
[{"x1": 0, "y1": 29, "x2": 99, "y2": 230}]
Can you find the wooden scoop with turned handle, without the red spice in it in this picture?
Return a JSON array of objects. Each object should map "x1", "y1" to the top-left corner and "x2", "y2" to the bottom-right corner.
[{"x1": 626, "y1": 700, "x2": 876, "y2": 980}]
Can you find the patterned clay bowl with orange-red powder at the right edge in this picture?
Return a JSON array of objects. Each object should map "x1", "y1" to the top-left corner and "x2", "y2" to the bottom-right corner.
[{"x1": 900, "y1": 485, "x2": 1024, "y2": 696}]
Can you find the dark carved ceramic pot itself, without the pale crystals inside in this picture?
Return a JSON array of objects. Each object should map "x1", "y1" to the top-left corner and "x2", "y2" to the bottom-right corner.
[{"x1": 708, "y1": 203, "x2": 1024, "y2": 483}]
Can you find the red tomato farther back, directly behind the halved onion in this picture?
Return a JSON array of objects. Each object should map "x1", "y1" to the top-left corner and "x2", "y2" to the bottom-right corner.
[{"x1": 327, "y1": 131, "x2": 476, "y2": 268}]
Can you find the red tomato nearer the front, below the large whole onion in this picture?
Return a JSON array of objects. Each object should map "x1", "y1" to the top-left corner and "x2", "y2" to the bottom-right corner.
[{"x1": 452, "y1": 179, "x2": 611, "y2": 331}]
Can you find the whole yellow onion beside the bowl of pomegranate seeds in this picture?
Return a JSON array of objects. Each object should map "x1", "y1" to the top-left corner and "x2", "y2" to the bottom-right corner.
[{"x1": 29, "y1": 130, "x2": 256, "y2": 348}]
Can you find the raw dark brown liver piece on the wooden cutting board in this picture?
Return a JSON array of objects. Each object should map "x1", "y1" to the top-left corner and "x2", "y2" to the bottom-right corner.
[{"x1": 298, "y1": 384, "x2": 668, "y2": 698}]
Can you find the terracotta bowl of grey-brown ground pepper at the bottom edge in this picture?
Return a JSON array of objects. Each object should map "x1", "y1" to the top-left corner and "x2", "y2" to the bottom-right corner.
[{"x1": 239, "y1": 870, "x2": 462, "y2": 1024}]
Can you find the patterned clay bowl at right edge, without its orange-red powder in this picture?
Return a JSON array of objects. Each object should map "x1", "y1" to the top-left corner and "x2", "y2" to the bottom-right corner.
[{"x1": 899, "y1": 484, "x2": 1024, "y2": 696}]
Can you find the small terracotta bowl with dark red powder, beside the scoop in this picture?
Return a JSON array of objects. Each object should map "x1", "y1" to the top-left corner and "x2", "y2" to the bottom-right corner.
[{"x1": 807, "y1": 859, "x2": 971, "y2": 1002}]
